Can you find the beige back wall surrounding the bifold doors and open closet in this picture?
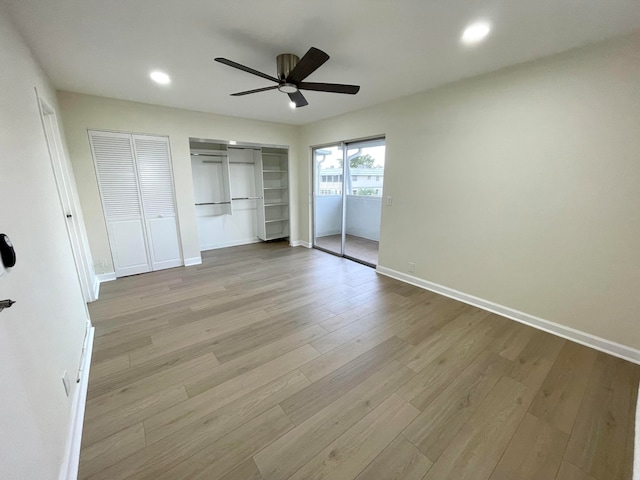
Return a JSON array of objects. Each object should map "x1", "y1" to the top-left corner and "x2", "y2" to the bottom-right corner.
[{"x1": 58, "y1": 92, "x2": 301, "y2": 273}]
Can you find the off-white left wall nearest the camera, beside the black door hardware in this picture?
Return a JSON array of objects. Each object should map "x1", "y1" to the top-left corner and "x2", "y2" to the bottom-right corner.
[{"x1": 0, "y1": 10, "x2": 87, "y2": 480}]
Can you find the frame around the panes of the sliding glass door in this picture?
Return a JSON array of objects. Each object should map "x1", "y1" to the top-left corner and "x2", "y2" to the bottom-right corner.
[{"x1": 311, "y1": 135, "x2": 386, "y2": 268}]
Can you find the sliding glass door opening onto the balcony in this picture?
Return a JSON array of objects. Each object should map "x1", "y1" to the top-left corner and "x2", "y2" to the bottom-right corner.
[{"x1": 313, "y1": 139, "x2": 385, "y2": 266}]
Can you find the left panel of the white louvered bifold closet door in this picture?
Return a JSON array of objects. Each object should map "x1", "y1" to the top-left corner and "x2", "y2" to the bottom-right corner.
[{"x1": 89, "y1": 131, "x2": 151, "y2": 277}]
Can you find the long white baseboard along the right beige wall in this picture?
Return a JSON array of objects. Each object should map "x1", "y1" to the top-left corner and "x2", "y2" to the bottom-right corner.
[{"x1": 376, "y1": 265, "x2": 640, "y2": 364}]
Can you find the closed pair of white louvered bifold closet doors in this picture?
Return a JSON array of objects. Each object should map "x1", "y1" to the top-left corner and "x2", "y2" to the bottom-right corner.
[{"x1": 89, "y1": 130, "x2": 183, "y2": 277}]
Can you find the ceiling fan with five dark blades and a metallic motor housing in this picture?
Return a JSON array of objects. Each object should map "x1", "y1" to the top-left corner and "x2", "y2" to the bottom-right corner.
[{"x1": 215, "y1": 47, "x2": 360, "y2": 108}]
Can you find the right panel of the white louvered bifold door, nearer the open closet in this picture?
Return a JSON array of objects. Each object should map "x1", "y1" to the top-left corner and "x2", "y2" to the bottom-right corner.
[{"x1": 132, "y1": 135, "x2": 183, "y2": 270}]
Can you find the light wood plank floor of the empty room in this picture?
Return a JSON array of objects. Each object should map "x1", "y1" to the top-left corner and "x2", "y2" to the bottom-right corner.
[{"x1": 80, "y1": 243, "x2": 640, "y2": 480}]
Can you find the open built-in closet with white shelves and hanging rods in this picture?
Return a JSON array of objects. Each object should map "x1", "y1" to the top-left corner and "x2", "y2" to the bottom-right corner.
[{"x1": 190, "y1": 139, "x2": 289, "y2": 250}]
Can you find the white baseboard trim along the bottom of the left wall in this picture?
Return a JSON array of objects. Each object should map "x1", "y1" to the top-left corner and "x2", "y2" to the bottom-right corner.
[{"x1": 59, "y1": 327, "x2": 95, "y2": 480}]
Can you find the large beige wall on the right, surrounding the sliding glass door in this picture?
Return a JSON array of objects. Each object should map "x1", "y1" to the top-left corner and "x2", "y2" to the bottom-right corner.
[{"x1": 298, "y1": 34, "x2": 640, "y2": 349}]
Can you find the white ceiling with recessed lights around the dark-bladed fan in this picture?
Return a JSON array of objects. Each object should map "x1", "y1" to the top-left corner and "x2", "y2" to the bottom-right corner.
[{"x1": 0, "y1": 0, "x2": 640, "y2": 125}]
